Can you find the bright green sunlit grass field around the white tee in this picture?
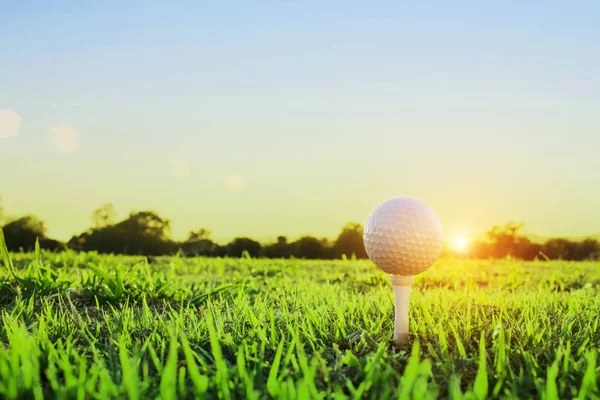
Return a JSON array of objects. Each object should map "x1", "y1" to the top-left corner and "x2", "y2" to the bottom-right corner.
[{"x1": 0, "y1": 236, "x2": 600, "y2": 399}]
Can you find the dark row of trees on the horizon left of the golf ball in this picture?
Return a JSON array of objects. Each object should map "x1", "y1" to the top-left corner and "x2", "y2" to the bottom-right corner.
[{"x1": 0, "y1": 204, "x2": 367, "y2": 259}]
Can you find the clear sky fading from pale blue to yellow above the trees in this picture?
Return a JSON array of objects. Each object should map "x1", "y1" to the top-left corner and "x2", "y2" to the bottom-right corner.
[{"x1": 0, "y1": 1, "x2": 600, "y2": 240}]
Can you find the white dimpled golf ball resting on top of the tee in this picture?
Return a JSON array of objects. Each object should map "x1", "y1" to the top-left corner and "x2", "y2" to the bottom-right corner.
[{"x1": 363, "y1": 197, "x2": 442, "y2": 275}]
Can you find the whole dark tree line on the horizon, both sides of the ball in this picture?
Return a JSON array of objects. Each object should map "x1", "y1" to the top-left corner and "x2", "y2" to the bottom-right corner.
[{"x1": 0, "y1": 198, "x2": 600, "y2": 261}]
